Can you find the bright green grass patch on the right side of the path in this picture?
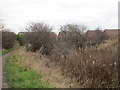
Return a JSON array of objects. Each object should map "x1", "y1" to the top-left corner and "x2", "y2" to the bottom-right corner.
[{"x1": 5, "y1": 55, "x2": 54, "y2": 88}]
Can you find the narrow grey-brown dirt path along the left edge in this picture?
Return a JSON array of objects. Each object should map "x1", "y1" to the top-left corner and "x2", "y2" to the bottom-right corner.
[{"x1": 0, "y1": 52, "x2": 12, "y2": 88}]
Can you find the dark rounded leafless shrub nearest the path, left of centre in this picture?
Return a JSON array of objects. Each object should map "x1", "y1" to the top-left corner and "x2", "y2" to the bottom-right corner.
[{"x1": 25, "y1": 23, "x2": 54, "y2": 55}]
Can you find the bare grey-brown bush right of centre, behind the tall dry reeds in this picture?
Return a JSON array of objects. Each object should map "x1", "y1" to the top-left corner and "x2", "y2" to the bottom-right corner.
[{"x1": 54, "y1": 24, "x2": 86, "y2": 59}]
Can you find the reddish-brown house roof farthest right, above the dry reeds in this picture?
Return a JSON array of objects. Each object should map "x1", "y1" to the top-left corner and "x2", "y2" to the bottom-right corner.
[{"x1": 103, "y1": 29, "x2": 119, "y2": 39}]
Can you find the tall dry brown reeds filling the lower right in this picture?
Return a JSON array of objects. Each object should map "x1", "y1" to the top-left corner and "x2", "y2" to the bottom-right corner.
[{"x1": 52, "y1": 41, "x2": 118, "y2": 88}]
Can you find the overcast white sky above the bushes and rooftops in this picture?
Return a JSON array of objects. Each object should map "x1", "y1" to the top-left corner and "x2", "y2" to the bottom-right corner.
[{"x1": 0, "y1": 0, "x2": 119, "y2": 32}]
